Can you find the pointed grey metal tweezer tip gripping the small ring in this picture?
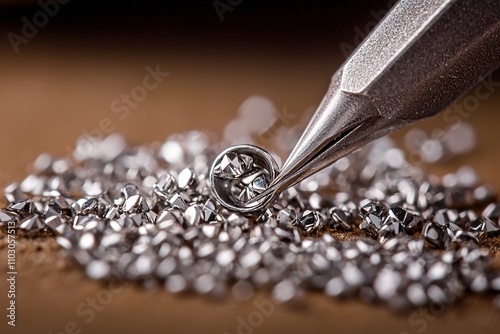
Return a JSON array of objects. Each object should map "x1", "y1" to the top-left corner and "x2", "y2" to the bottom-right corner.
[{"x1": 249, "y1": 0, "x2": 500, "y2": 203}]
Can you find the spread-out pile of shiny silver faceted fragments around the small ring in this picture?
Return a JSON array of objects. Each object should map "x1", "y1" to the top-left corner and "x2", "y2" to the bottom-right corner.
[{"x1": 0, "y1": 101, "x2": 500, "y2": 309}]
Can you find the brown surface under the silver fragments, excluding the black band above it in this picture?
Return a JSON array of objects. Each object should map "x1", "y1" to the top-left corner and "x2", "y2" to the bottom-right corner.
[{"x1": 0, "y1": 3, "x2": 500, "y2": 334}]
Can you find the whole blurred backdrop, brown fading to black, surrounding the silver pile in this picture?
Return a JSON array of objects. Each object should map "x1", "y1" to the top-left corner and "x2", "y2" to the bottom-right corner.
[{"x1": 0, "y1": 0, "x2": 500, "y2": 334}]
